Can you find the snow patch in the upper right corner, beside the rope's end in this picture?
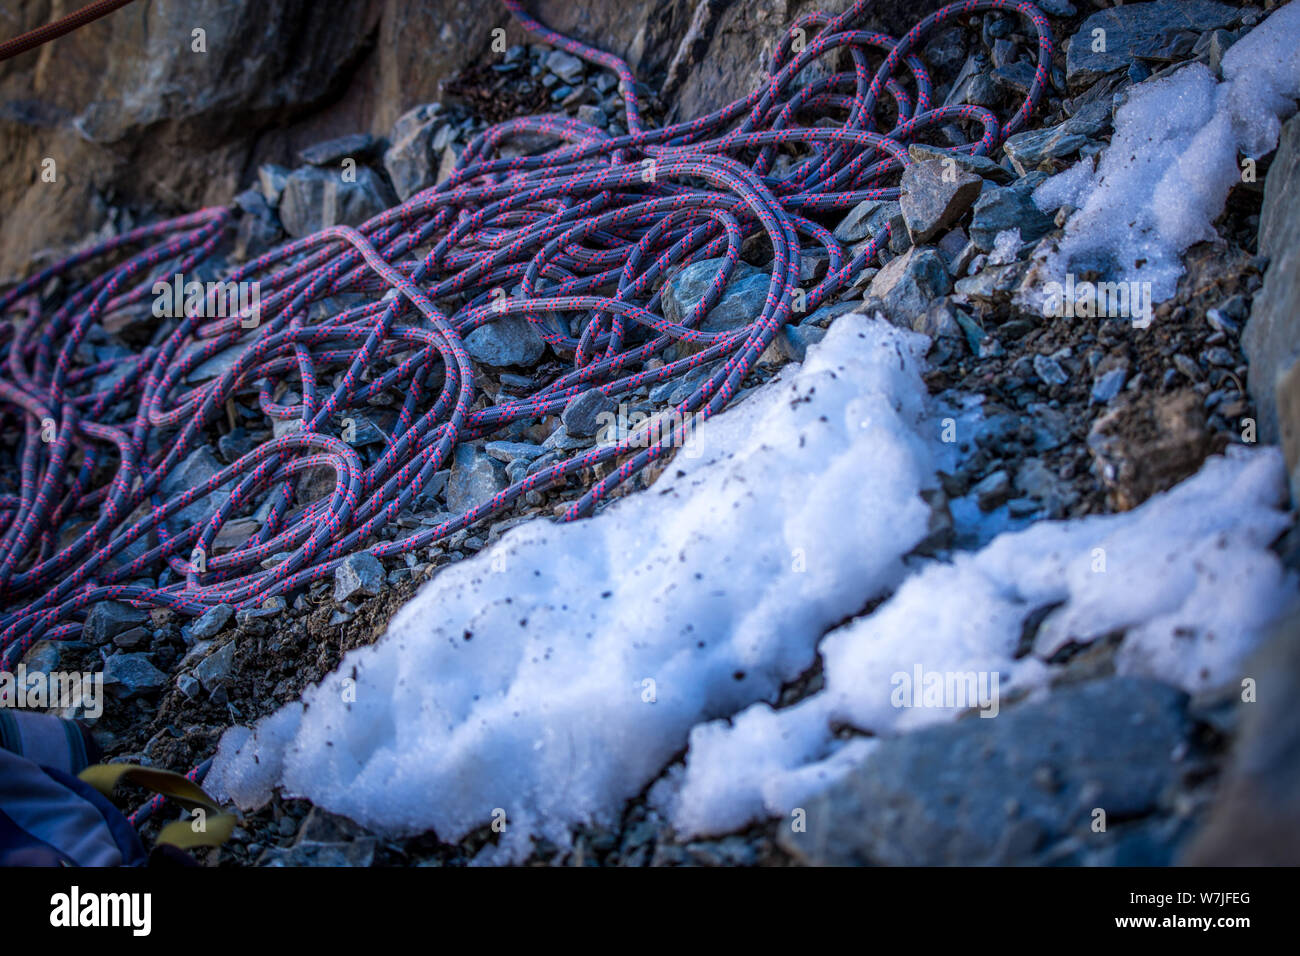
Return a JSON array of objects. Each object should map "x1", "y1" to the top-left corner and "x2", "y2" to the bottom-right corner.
[{"x1": 1035, "y1": 3, "x2": 1300, "y2": 302}]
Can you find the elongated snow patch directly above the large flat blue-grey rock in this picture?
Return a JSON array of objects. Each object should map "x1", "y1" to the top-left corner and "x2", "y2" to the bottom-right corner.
[{"x1": 664, "y1": 449, "x2": 1295, "y2": 835}]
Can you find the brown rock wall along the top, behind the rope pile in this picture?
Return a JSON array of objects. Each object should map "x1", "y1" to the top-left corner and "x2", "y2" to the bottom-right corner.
[{"x1": 0, "y1": 0, "x2": 943, "y2": 278}]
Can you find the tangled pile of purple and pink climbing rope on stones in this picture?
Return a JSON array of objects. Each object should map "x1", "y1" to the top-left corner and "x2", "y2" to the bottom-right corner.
[{"x1": 0, "y1": 0, "x2": 1052, "y2": 669}]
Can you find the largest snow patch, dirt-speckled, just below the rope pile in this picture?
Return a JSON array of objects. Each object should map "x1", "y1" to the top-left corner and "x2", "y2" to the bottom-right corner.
[{"x1": 208, "y1": 316, "x2": 936, "y2": 862}]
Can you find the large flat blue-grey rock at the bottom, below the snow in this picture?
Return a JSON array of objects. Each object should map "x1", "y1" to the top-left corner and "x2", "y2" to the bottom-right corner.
[{"x1": 779, "y1": 678, "x2": 1190, "y2": 866}]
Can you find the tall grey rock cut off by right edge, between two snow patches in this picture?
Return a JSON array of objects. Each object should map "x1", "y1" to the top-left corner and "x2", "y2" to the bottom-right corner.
[{"x1": 1242, "y1": 116, "x2": 1300, "y2": 501}]
